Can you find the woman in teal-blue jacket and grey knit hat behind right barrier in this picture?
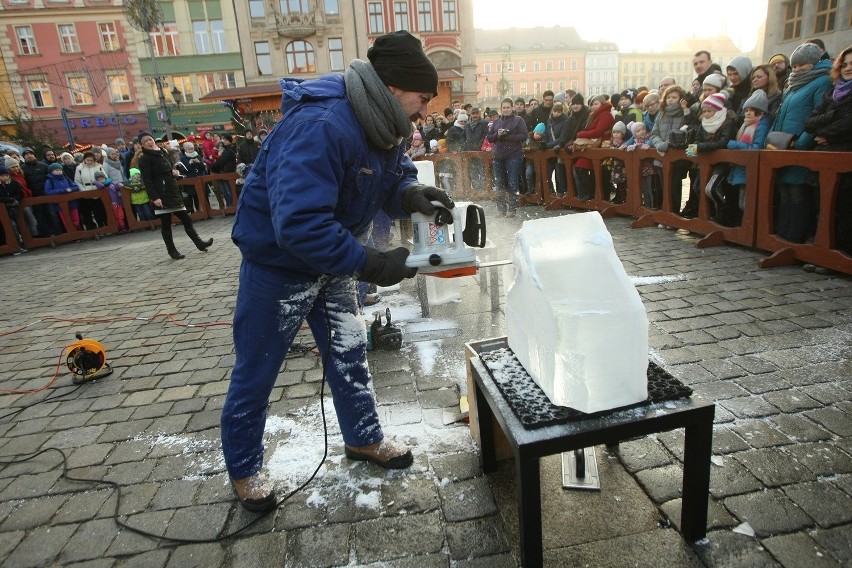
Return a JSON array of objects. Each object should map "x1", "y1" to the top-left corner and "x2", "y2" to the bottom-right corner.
[{"x1": 772, "y1": 43, "x2": 831, "y2": 243}]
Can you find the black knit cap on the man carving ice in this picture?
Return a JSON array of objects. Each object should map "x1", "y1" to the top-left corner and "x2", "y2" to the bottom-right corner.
[{"x1": 367, "y1": 30, "x2": 438, "y2": 95}]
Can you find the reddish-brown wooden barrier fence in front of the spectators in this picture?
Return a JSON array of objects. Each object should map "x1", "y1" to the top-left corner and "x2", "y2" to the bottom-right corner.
[{"x1": 0, "y1": 148, "x2": 852, "y2": 274}]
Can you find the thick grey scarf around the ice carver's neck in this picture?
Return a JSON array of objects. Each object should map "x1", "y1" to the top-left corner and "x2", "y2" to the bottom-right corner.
[{"x1": 344, "y1": 59, "x2": 412, "y2": 150}]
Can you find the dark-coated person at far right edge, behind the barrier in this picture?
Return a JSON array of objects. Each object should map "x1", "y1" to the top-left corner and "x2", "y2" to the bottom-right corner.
[{"x1": 805, "y1": 46, "x2": 852, "y2": 255}]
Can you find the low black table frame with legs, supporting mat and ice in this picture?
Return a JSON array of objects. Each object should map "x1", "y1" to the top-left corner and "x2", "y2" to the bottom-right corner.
[{"x1": 468, "y1": 340, "x2": 715, "y2": 567}]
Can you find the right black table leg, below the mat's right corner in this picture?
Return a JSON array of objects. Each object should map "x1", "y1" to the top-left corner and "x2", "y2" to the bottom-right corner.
[{"x1": 680, "y1": 415, "x2": 713, "y2": 542}]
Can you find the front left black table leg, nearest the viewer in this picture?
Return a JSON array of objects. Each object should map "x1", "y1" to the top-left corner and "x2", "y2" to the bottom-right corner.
[{"x1": 515, "y1": 455, "x2": 544, "y2": 568}]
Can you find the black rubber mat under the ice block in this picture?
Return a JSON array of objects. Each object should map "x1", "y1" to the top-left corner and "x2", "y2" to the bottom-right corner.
[{"x1": 479, "y1": 347, "x2": 692, "y2": 430}]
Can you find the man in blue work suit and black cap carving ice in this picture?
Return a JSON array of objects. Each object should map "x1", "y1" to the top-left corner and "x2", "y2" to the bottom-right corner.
[{"x1": 221, "y1": 31, "x2": 454, "y2": 511}]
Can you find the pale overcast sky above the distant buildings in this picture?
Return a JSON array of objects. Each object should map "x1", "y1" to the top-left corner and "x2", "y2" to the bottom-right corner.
[{"x1": 473, "y1": 0, "x2": 767, "y2": 52}]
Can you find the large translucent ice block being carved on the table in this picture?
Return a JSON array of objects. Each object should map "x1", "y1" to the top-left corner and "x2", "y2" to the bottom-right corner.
[{"x1": 506, "y1": 212, "x2": 648, "y2": 413}]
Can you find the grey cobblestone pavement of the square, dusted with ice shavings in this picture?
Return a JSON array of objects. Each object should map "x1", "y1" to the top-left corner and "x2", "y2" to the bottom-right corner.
[{"x1": 0, "y1": 204, "x2": 852, "y2": 568}]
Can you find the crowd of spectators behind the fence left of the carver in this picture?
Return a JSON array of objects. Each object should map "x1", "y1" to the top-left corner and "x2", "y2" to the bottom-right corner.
[{"x1": 0, "y1": 130, "x2": 267, "y2": 254}]
